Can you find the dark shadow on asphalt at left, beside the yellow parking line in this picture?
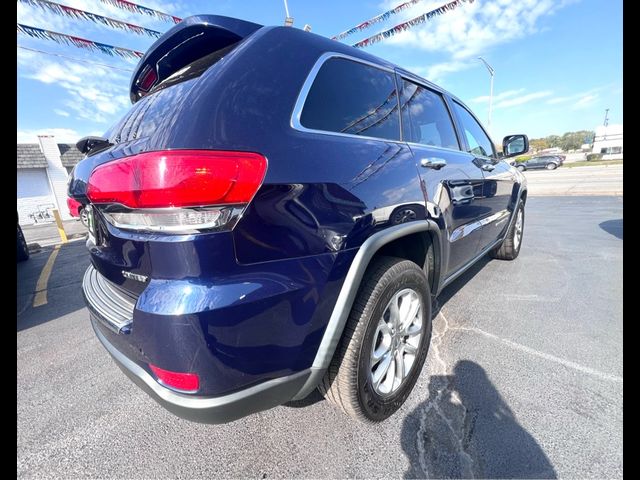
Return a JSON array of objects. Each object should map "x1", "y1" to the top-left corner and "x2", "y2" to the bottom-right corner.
[{"x1": 16, "y1": 241, "x2": 90, "y2": 332}]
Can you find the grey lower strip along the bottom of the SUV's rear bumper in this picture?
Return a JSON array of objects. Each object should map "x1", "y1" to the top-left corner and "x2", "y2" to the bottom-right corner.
[{"x1": 91, "y1": 314, "x2": 311, "y2": 423}]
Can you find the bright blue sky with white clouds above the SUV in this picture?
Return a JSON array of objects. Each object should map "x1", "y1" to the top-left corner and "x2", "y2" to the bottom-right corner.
[{"x1": 17, "y1": 0, "x2": 622, "y2": 142}]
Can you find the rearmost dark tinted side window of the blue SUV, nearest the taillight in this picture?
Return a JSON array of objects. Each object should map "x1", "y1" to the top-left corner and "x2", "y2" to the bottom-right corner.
[{"x1": 300, "y1": 58, "x2": 400, "y2": 140}]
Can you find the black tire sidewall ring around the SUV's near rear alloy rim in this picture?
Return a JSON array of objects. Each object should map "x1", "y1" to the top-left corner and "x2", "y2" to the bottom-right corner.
[{"x1": 357, "y1": 267, "x2": 431, "y2": 421}]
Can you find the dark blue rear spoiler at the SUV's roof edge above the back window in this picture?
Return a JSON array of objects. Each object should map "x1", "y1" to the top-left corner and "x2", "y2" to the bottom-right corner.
[{"x1": 129, "y1": 15, "x2": 262, "y2": 103}]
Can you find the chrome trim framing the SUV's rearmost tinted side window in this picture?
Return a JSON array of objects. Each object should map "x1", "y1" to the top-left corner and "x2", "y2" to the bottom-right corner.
[{"x1": 290, "y1": 52, "x2": 406, "y2": 144}]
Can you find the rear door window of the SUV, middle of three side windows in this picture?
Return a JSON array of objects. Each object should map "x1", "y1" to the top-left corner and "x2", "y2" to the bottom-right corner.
[{"x1": 400, "y1": 79, "x2": 460, "y2": 149}]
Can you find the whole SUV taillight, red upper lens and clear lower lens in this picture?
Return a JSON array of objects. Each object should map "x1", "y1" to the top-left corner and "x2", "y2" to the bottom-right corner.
[{"x1": 87, "y1": 150, "x2": 267, "y2": 233}]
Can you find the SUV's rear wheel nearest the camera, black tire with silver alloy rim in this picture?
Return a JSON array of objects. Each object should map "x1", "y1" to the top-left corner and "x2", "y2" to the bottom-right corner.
[{"x1": 318, "y1": 257, "x2": 431, "y2": 422}]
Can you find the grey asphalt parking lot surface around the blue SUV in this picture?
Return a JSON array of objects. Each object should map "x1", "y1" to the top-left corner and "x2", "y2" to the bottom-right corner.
[{"x1": 17, "y1": 193, "x2": 623, "y2": 478}]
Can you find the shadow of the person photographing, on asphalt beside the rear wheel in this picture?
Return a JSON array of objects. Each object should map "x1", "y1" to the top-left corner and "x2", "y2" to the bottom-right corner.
[{"x1": 401, "y1": 360, "x2": 557, "y2": 478}]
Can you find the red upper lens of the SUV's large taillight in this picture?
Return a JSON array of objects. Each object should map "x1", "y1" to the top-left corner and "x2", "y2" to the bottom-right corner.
[{"x1": 87, "y1": 150, "x2": 267, "y2": 208}]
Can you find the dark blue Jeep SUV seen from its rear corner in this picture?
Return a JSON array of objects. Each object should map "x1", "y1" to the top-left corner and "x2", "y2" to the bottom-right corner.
[{"x1": 69, "y1": 15, "x2": 528, "y2": 423}]
